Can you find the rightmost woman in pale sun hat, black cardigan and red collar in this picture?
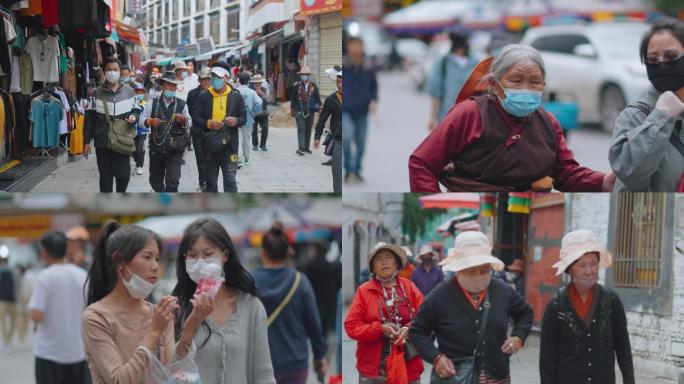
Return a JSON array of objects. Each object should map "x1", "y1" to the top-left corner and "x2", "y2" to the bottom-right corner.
[{"x1": 539, "y1": 230, "x2": 634, "y2": 384}]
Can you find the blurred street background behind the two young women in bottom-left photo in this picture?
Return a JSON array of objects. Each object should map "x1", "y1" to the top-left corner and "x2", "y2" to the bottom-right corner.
[{"x1": 0, "y1": 193, "x2": 342, "y2": 384}]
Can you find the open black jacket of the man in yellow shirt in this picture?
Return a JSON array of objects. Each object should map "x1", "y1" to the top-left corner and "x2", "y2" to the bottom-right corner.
[{"x1": 191, "y1": 88, "x2": 247, "y2": 159}]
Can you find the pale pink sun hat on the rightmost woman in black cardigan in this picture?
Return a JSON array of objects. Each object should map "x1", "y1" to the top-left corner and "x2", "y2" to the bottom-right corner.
[{"x1": 553, "y1": 229, "x2": 613, "y2": 276}]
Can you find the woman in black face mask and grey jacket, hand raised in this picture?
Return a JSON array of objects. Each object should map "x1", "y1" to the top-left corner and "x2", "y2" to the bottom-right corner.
[{"x1": 608, "y1": 18, "x2": 684, "y2": 192}]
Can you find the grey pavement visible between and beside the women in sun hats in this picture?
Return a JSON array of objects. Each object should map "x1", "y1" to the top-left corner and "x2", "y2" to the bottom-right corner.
[{"x1": 342, "y1": 311, "x2": 675, "y2": 384}]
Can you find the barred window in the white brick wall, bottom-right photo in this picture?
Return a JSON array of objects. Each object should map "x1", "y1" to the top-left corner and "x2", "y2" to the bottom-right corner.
[{"x1": 613, "y1": 193, "x2": 665, "y2": 288}]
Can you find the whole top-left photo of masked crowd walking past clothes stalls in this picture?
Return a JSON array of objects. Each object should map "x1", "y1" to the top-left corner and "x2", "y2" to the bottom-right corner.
[{"x1": 0, "y1": 0, "x2": 343, "y2": 193}]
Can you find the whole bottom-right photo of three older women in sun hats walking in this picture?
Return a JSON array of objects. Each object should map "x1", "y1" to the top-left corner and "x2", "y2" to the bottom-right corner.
[{"x1": 342, "y1": 192, "x2": 684, "y2": 384}]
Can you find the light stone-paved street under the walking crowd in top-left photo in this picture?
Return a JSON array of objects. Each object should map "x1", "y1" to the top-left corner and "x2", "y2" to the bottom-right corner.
[{"x1": 31, "y1": 128, "x2": 332, "y2": 192}]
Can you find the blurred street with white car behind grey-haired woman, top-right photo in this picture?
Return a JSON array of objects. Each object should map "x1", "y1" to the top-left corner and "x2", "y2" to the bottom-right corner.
[{"x1": 343, "y1": 0, "x2": 684, "y2": 192}]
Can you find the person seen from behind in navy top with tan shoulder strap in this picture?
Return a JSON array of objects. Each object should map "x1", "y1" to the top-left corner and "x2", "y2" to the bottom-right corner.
[{"x1": 253, "y1": 227, "x2": 328, "y2": 384}]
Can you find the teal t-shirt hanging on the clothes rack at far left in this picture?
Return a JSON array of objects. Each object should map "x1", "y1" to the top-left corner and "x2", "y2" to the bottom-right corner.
[{"x1": 29, "y1": 96, "x2": 64, "y2": 148}]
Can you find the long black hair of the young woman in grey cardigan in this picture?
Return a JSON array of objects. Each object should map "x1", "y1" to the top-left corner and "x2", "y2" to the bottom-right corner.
[{"x1": 171, "y1": 218, "x2": 257, "y2": 346}]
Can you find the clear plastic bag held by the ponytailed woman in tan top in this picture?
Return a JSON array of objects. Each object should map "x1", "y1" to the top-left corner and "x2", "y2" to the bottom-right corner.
[{"x1": 145, "y1": 342, "x2": 202, "y2": 384}]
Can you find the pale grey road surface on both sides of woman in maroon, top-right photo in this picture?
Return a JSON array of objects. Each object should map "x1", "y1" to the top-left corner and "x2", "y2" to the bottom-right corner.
[{"x1": 344, "y1": 72, "x2": 610, "y2": 192}]
